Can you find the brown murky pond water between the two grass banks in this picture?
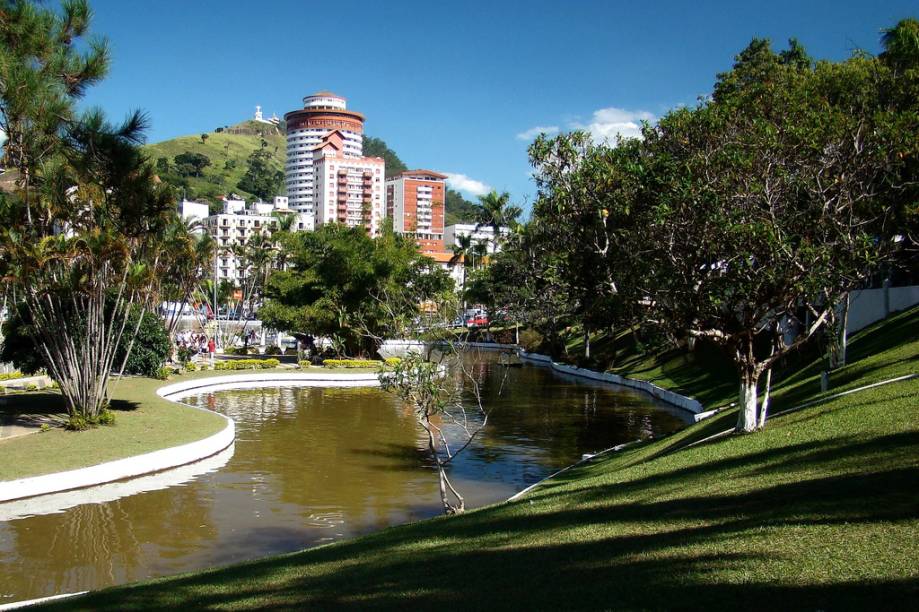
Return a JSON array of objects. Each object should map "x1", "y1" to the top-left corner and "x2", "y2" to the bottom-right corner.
[{"x1": 0, "y1": 360, "x2": 689, "y2": 604}]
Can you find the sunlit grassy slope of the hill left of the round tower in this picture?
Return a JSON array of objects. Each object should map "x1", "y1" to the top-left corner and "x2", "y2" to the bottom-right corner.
[{"x1": 144, "y1": 122, "x2": 287, "y2": 198}]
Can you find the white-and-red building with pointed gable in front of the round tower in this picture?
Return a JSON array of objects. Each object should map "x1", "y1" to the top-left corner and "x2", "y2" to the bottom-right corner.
[{"x1": 313, "y1": 130, "x2": 386, "y2": 236}]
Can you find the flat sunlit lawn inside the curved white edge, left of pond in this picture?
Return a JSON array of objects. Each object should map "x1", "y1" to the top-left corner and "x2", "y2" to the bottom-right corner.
[{"x1": 0, "y1": 368, "x2": 372, "y2": 481}]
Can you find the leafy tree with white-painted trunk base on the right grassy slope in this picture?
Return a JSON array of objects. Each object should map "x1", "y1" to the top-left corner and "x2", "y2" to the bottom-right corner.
[{"x1": 638, "y1": 41, "x2": 904, "y2": 431}]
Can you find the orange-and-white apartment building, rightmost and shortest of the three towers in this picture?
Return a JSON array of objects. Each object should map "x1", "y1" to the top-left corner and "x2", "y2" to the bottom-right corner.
[{"x1": 386, "y1": 170, "x2": 447, "y2": 254}]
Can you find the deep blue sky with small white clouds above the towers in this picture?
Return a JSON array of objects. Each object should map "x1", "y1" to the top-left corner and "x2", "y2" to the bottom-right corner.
[{"x1": 86, "y1": 0, "x2": 919, "y2": 209}]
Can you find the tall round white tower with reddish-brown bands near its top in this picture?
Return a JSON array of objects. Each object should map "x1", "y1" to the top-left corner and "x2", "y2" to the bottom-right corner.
[{"x1": 284, "y1": 91, "x2": 364, "y2": 214}]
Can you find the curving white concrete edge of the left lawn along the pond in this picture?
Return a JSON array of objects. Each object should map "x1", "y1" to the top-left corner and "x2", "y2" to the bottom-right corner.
[{"x1": 0, "y1": 372, "x2": 379, "y2": 503}]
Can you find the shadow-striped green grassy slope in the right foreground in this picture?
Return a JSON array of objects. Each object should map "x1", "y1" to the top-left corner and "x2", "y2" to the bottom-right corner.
[{"x1": 48, "y1": 309, "x2": 919, "y2": 610}]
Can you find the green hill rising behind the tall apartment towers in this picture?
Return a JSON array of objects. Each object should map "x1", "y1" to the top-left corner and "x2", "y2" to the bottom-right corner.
[{"x1": 144, "y1": 121, "x2": 477, "y2": 225}]
